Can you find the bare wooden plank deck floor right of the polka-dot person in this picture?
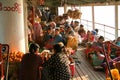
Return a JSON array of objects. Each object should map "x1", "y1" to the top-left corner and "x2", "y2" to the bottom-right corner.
[{"x1": 72, "y1": 48, "x2": 106, "y2": 80}]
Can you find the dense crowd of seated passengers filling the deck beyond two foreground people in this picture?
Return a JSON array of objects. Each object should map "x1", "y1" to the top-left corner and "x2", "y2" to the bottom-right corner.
[{"x1": 25, "y1": 6, "x2": 120, "y2": 80}]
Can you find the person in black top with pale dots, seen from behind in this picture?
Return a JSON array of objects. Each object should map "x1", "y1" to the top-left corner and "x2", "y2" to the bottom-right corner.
[{"x1": 42, "y1": 44, "x2": 71, "y2": 80}]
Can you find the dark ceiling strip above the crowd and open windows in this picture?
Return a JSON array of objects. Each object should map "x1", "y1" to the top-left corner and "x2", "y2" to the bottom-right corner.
[{"x1": 27, "y1": 0, "x2": 120, "y2": 7}]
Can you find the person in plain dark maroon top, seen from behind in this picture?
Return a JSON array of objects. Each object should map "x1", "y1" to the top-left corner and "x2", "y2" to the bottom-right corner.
[{"x1": 18, "y1": 43, "x2": 43, "y2": 80}]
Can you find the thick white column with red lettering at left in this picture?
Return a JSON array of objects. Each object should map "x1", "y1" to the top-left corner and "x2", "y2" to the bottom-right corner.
[{"x1": 0, "y1": 0, "x2": 26, "y2": 52}]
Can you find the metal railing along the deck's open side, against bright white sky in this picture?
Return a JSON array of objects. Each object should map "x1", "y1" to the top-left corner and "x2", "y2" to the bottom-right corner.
[{"x1": 80, "y1": 19, "x2": 120, "y2": 40}]
